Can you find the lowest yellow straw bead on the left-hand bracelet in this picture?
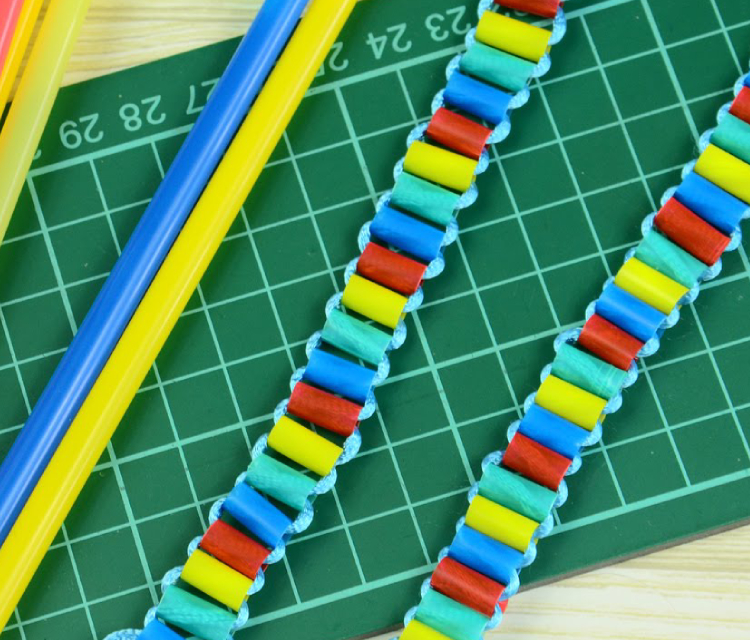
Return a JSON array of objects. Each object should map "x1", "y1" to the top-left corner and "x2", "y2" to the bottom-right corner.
[{"x1": 180, "y1": 549, "x2": 253, "y2": 611}]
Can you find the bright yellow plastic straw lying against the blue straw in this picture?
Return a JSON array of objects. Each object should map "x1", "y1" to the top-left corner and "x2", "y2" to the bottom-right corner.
[{"x1": 0, "y1": 0, "x2": 356, "y2": 630}]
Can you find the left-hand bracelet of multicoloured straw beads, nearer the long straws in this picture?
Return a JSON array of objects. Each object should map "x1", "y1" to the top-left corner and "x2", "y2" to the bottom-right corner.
[{"x1": 108, "y1": 0, "x2": 566, "y2": 640}]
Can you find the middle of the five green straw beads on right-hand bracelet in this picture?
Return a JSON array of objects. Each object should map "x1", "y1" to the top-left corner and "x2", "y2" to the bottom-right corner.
[{"x1": 552, "y1": 343, "x2": 628, "y2": 400}]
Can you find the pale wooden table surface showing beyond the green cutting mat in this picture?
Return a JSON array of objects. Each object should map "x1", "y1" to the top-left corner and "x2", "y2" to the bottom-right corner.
[{"x1": 26, "y1": 0, "x2": 750, "y2": 640}]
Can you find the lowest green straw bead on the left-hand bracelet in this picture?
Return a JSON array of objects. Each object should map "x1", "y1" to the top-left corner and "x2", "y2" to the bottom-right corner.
[{"x1": 156, "y1": 585, "x2": 237, "y2": 640}]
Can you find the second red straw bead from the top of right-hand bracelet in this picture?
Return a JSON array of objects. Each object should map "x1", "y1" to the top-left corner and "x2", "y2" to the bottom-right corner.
[{"x1": 654, "y1": 198, "x2": 730, "y2": 267}]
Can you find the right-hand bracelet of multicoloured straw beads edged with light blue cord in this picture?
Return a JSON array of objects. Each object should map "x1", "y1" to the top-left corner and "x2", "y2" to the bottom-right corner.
[{"x1": 400, "y1": 55, "x2": 750, "y2": 640}]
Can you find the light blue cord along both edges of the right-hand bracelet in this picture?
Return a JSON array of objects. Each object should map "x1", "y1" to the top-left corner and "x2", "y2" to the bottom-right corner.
[{"x1": 405, "y1": 40, "x2": 750, "y2": 630}]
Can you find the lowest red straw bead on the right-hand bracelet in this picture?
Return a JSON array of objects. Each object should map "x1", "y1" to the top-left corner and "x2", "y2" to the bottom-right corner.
[{"x1": 430, "y1": 558, "x2": 505, "y2": 618}]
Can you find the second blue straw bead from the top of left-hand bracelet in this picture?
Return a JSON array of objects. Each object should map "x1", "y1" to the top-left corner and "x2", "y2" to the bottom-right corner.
[{"x1": 370, "y1": 207, "x2": 445, "y2": 262}]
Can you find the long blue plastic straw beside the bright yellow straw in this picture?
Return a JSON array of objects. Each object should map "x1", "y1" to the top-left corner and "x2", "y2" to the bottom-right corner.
[{"x1": 0, "y1": 0, "x2": 308, "y2": 544}]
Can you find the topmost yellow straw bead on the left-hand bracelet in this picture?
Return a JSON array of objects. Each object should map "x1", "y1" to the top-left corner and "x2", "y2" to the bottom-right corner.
[{"x1": 476, "y1": 11, "x2": 552, "y2": 62}]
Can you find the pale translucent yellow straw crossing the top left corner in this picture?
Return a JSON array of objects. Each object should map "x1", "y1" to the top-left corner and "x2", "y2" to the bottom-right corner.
[{"x1": 0, "y1": 0, "x2": 91, "y2": 243}]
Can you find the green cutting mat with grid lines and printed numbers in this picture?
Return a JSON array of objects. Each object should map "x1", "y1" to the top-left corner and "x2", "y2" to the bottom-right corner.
[{"x1": 0, "y1": 0, "x2": 750, "y2": 640}]
